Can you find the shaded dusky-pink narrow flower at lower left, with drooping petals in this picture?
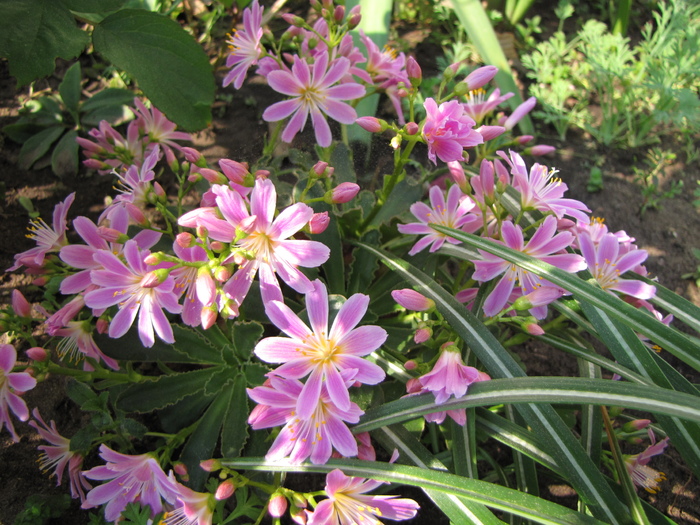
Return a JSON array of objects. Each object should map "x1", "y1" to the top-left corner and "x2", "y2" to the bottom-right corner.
[{"x1": 29, "y1": 408, "x2": 92, "y2": 502}]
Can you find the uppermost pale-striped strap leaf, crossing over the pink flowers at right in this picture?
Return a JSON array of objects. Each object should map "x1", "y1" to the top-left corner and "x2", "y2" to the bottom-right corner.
[{"x1": 433, "y1": 224, "x2": 700, "y2": 370}]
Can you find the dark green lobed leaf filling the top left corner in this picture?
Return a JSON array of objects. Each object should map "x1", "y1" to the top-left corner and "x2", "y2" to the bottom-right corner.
[{"x1": 0, "y1": 0, "x2": 90, "y2": 86}]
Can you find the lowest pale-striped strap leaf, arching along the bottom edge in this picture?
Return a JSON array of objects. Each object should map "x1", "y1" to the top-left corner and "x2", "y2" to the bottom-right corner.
[{"x1": 227, "y1": 458, "x2": 604, "y2": 525}]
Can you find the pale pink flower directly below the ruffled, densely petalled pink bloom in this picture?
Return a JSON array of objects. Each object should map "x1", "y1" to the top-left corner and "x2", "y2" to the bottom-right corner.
[{"x1": 398, "y1": 186, "x2": 480, "y2": 255}]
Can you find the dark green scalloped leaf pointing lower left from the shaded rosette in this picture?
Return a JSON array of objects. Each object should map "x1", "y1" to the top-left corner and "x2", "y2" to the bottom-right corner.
[{"x1": 117, "y1": 367, "x2": 220, "y2": 413}]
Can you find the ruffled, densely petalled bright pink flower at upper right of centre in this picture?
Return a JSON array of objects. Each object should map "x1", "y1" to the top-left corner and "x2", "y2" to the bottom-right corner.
[{"x1": 423, "y1": 98, "x2": 484, "y2": 164}]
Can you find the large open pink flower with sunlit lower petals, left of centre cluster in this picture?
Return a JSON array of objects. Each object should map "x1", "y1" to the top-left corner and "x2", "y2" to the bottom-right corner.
[{"x1": 85, "y1": 239, "x2": 182, "y2": 347}]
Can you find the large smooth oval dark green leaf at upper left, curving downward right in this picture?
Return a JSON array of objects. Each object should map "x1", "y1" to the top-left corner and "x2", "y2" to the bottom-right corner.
[{"x1": 92, "y1": 9, "x2": 216, "y2": 130}]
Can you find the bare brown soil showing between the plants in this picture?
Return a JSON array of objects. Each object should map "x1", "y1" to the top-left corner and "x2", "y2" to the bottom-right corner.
[{"x1": 0, "y1": 15, "x2": 700, "y2": 525}]
